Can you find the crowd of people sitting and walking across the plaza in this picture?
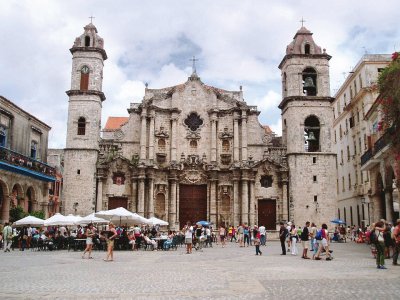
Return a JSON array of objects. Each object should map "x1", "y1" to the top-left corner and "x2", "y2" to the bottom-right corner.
[{"x1": 0, "y1": 219, "x2": 400, "y2": 269}]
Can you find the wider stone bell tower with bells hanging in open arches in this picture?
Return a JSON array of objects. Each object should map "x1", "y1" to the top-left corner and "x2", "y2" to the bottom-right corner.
[{"x1": 279, "y1": 26, "x2": 337, "y2": 226}]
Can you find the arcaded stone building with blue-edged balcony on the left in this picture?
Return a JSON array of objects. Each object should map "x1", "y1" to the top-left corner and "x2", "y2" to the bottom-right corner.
[{"x1": 0, "y1": 96, "x2": 55, "y2": 223}]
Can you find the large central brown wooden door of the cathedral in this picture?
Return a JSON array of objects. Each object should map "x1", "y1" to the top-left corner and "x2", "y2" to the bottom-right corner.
[{"x1": 179, "y1": 184, "x2": 207, "y2": 228}]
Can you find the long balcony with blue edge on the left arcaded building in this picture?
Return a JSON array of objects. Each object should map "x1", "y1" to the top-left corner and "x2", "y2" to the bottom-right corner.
[{"x1": 0, "y1": 146, "x2": 56, "y2": 182}]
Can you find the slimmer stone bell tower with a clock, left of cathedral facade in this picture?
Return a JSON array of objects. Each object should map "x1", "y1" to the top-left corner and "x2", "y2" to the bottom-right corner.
[{"x1": 63, "y1": 23, "x2": 107, "y2": 215}]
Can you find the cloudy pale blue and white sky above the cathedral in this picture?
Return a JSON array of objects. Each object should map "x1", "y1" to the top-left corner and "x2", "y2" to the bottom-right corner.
[{"x1": 0, "y1": 0, "x2": 400, "y2": 148}]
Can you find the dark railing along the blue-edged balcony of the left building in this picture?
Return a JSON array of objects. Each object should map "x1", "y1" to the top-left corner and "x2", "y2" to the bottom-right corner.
[{"x1": 0, "y1": 146, "x2": 56, "y2": 176}]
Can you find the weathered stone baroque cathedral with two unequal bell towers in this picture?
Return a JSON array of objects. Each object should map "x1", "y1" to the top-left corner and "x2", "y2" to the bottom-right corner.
[{"x1": 63, "y1": 23, "x2": 337, "y2": 230}]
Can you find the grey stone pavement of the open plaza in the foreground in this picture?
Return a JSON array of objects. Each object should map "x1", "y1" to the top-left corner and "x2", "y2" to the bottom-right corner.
[{"x1": 0, "y1": 241, "x2": 400, "y2": 299}]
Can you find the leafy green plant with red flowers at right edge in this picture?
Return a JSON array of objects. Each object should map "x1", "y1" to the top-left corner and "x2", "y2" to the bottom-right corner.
[{"x1": 378, "y1": 52, "x2": 400, "y2": 186}]
